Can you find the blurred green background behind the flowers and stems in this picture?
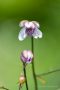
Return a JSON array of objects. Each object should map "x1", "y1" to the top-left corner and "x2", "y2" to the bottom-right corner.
[{"x1": 0, "y1": 0, "x2": 60, "y2": 90}]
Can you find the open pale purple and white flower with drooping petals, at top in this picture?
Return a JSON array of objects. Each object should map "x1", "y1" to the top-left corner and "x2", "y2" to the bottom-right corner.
[{"x1": 18, "y1": 20, "x2": 42, "y2": 41}]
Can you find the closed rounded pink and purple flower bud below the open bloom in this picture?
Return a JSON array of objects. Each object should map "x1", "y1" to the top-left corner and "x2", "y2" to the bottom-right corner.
[{"x1": 20, "y1": 50, "x2": 33, "y2": 63}]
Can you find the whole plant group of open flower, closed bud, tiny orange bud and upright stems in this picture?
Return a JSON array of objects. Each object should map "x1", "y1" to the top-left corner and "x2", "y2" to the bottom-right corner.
[{"x1": 18, "y1": 20, "x2": 42, "y2": 90}]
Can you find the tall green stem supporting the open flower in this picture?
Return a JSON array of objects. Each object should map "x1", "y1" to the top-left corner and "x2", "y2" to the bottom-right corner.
[{"x1": 31, "y1": 37, "x2": 38, "y2": 90}]
